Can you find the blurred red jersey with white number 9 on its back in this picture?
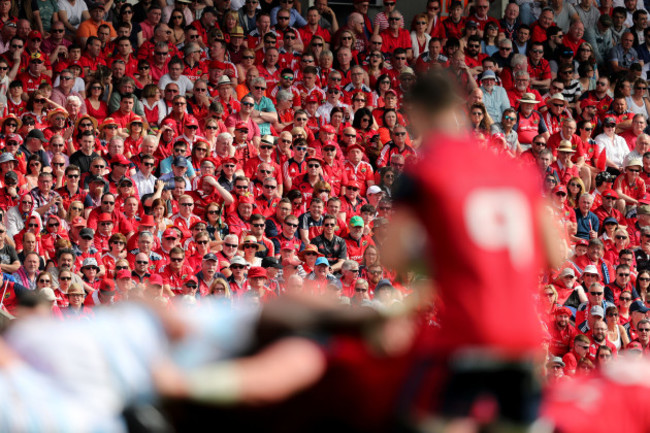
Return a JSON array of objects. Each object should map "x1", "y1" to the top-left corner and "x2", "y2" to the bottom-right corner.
[{"x1": 402, "y1": 135, "x2": 542, "y2": 354}]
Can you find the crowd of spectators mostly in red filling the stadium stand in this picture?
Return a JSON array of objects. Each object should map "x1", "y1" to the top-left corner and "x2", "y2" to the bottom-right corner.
[{"x1": 0, "y1": 0, "x2": 650, "y2": 380}]
